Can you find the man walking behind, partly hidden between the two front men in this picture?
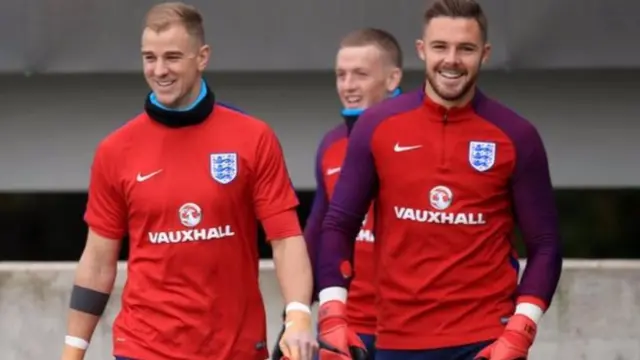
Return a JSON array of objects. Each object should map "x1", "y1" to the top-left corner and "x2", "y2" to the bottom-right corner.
[{"x1": 274, "y1": 28, "x2": 402, "y2": 359}]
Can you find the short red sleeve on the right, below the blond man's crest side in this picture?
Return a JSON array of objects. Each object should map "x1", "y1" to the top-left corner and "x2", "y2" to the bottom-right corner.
[{"x1": 253, "y1": 127, "x2": 298, "y2": 222}]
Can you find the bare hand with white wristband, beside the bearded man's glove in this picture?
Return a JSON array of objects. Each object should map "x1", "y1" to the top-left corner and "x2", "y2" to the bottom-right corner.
[{"x1": 274, "y1": 304, "x2": 318, "y2": 360}]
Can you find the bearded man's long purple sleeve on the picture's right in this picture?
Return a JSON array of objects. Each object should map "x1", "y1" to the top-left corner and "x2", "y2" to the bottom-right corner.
[{"x1": 477, "y1": 95, "x2": 562, "y2": 306}]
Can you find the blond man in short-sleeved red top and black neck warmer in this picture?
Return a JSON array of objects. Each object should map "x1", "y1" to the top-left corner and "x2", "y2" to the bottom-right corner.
[{"x1": 62, "y1": 3, "x2": 316, "y2": 360}]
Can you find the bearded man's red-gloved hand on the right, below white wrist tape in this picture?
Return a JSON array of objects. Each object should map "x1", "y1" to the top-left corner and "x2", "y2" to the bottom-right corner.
[{"x1": 475, "y1": 314, "x2": 537, "y2": 360}]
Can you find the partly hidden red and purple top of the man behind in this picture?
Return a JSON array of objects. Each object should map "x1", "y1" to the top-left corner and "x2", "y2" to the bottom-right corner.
[{"x1": 304, "y1": 123, "x2": 376, "y2": 334}]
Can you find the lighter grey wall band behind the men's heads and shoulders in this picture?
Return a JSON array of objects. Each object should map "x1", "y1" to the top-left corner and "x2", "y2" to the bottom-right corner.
[{"x1": 0, "y1": 70, "x2": 640, "y2": 191}]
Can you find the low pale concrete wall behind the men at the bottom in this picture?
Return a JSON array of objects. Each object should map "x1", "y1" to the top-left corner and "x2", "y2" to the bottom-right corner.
[{"x1": 0, "y1": 261, "x2": 640, "y2": 360}]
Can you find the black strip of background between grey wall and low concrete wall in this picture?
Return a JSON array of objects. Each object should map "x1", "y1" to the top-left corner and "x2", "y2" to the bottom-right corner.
[{"x1": 0, "y1": 188, "x2": 640, "y2": 261}]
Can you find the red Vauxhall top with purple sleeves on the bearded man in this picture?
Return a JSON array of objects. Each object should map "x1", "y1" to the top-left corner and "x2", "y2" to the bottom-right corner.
[{"x1": 318, "y1": 90, "x2": 562, "y2": 349}]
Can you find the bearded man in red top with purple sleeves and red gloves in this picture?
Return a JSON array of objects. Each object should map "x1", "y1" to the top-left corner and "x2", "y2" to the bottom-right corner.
[{"x1": 318, "y1": 0, "x2": 562, "y2": 360}]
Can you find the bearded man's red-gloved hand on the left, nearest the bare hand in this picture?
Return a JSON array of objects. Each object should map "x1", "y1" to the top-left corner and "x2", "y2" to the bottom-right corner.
[{"x1": 318, "y1": 300, "x2": 368, "y2": 360}]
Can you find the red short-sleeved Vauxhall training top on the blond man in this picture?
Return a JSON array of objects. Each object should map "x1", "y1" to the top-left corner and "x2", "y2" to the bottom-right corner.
[{"x1": 85, "y1": 105, "x2": 301, "y2": 360}]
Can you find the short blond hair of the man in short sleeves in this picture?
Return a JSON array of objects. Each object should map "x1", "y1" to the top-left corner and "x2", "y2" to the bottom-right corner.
[{"x1": 144, "y1": 2, "x2": 204, "y2": 43}]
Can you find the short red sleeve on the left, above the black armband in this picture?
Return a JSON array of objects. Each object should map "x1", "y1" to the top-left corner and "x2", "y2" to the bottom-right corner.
[{"x1": 84, "y1": 143, "x2": 127, "y2": 240}]
